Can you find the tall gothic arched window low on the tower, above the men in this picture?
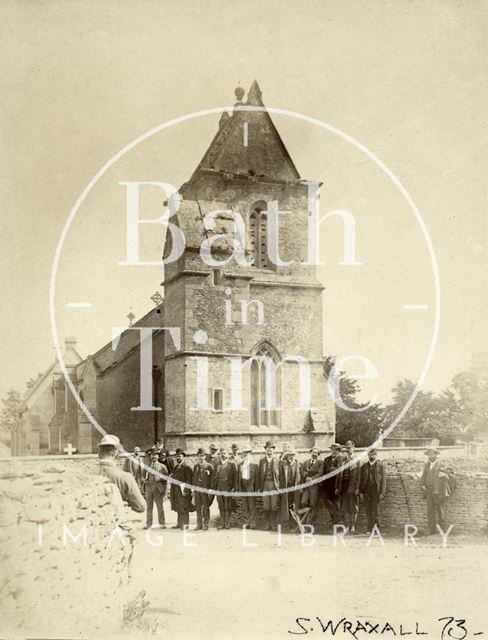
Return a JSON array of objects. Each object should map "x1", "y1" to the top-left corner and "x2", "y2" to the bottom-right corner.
[{"x1": 251, "y1": 344, "x2": 281, "y2": 427}]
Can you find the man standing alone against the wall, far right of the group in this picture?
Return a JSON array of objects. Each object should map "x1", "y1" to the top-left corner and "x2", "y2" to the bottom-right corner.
[{"x1": 420, "y1": 447, "x2": 453, "y2": 534}]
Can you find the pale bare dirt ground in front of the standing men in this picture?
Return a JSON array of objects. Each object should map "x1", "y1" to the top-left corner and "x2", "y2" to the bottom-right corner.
[{"x1": 127, "y1": 509, "x2": 488, "y2": 640}]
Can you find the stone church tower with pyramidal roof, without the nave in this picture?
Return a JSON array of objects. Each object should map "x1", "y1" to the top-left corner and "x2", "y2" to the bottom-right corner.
[{"x1": 163, "y1": 80, "x2": 335, "y2": 451}]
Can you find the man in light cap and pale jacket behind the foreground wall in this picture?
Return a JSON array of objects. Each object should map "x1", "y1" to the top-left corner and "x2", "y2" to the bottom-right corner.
[{"x1": 97, "y1": 434, "x2": 146, "y2": 513}]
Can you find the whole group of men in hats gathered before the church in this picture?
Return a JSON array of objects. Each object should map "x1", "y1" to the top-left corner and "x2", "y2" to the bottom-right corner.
[{"x1": 99, "y1": 436, "x2": 453, "y2": 533}]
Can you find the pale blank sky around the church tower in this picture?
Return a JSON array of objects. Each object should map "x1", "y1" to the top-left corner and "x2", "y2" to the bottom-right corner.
[{"x1": 0, "y1": 0, "x2": 488, "y2": 402}]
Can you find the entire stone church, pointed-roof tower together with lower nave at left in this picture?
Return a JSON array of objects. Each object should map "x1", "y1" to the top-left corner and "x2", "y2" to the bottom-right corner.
[{"x1": 14, "y1": 82, "x2": 335, "y2": 453}]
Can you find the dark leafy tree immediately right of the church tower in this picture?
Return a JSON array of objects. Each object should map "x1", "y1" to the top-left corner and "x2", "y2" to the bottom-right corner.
[{"x1": 323, "y1": 356, "x2": 383, "y2": 447}]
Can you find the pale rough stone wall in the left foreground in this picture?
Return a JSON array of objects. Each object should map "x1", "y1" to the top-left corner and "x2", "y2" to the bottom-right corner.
[{"x1": 0, "y1": 462, "x2": 137, "y2": 637}]
